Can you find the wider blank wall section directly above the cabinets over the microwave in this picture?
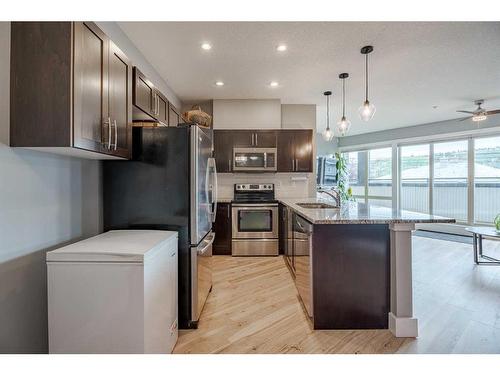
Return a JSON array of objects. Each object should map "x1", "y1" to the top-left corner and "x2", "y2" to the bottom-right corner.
[{"x1": 213, "y1": 99, "x2": 281, "y2": 129}]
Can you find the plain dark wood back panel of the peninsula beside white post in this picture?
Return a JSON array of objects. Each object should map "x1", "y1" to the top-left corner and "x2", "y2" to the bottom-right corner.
[{"x1": 312, "y1": 224, "x2": 390, "y2": 329}]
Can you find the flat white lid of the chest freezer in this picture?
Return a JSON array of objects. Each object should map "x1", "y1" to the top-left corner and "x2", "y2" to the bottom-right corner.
[{"x1": 46, "y1": 230, "x2": 178, "y2": 263}]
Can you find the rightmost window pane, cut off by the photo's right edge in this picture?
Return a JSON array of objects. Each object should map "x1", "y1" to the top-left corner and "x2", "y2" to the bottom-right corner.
[{"x1": 474, "y1": 137, "x2": 500, "y2": 224}]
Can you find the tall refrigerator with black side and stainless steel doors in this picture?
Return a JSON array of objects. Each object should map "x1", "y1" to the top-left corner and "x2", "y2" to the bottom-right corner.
[{"x1": 103, "y1": 125, "x2": 217, "y2": 328}]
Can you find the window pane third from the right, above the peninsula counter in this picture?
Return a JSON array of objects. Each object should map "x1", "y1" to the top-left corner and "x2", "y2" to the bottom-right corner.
[{"x1": 400, "y1": 144, "x2": 430, "y2": 213}]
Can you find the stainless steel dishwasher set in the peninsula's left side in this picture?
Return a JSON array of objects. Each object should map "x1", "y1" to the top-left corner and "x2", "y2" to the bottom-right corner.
[{"x1": 293, "y1": 214, "x2": 313, "y2": 317}]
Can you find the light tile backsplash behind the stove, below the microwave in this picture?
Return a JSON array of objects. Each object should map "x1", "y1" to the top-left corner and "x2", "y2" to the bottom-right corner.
[{"x1": 217, "y1": 173, "x2": 316, "y2": 199}]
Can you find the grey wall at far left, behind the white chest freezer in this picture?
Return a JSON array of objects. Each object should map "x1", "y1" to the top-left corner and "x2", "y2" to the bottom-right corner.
[{"x1": 0, "y1": 22, "x2": 102, "y2": 353}]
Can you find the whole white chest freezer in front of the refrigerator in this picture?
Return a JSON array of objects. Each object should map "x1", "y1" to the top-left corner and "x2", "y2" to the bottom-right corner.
[{"x1": 47, "y1": 230, "x2": 178, "y2": 353}]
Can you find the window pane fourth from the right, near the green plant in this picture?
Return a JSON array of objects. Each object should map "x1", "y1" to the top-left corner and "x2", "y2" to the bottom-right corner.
[{"x1": 368, "y1": 147, "x2": 392, "y2": 207}]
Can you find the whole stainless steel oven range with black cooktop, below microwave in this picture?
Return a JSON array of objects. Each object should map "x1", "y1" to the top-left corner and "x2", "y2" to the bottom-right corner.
[{"x1": 231, "y1": 184, "x2": 278, "y2": 256}]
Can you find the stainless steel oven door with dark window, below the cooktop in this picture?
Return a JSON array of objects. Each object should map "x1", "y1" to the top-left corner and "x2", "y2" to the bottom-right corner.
[{"x1": 232, "y1": 203, "x2": 278, "y2": 239}]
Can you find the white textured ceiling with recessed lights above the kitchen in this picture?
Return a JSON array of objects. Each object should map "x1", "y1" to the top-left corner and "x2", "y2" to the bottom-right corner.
[{"x1": 119, "y1": 22, "x2": 500, "y2": 135}]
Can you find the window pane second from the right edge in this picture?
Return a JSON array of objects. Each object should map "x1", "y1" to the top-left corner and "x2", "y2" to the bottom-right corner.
[{"x1": 432, "y1": 140, "x2": 468, "y2": 222}]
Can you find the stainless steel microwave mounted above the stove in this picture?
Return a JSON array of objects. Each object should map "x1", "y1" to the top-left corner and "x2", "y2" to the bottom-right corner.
[{"x1": 233, "y1": 147, "x2": 277, "y2": 172}]
